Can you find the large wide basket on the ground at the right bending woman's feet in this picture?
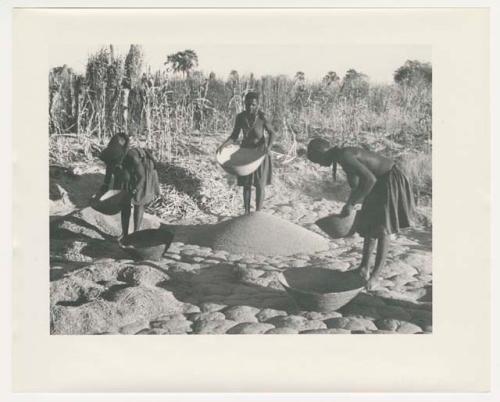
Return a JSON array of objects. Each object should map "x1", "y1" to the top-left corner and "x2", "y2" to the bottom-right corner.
[{"x1": 281, "y1": 268, "x2": 365, "y2": 312}]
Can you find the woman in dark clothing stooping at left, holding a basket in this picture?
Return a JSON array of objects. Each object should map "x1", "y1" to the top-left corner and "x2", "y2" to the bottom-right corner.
[{"x1": 100, "y1": 133, "x2": 160, "y2": 239}]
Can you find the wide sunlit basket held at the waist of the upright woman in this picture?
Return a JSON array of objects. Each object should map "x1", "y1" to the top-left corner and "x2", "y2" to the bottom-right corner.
[{"x1": 215, "y1": 144, "x2": 266, "y2": 176}]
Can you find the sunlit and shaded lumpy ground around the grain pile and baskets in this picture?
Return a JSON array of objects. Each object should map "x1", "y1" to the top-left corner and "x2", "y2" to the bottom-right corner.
[{"x1": 50, "y1": 163, "x2": 432, "y2": 334}]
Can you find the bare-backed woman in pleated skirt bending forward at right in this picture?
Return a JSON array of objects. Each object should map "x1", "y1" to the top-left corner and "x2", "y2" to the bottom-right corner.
[{"x1": 307, "y1": 138, "x2": 415, "y2": 290}]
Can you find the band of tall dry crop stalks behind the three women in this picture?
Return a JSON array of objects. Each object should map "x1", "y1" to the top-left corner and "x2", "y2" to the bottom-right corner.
[{"x1": 49, "y1": 47, "x2": 432, "y2": 152}]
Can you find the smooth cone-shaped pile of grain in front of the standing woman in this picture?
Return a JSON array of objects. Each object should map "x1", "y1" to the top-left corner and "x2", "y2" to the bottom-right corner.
[{"x1": 195, "y1": 212, "x2": 328, "y2": 255}]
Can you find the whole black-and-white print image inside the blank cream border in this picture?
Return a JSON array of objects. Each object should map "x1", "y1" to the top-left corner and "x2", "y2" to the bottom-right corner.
[{"x1": 47, "y1": 42, "x2": 433, "y2": 335}]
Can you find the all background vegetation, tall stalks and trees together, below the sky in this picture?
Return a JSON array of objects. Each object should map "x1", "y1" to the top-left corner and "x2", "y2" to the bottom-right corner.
[{"x1": 49, "y1": 45, "x2": 432, "y2": 221}]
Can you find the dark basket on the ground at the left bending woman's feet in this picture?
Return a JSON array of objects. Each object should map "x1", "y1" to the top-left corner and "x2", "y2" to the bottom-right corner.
[{"x1": 122, "y1": 229, "x2": 174, "y2": 261}]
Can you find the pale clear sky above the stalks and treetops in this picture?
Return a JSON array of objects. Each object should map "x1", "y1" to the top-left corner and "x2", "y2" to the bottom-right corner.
[{"x1": 49, "y1": 42, "x2": 431, "y2": 83}]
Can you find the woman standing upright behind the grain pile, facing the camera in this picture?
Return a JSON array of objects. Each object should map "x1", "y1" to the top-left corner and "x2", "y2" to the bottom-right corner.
[{"x1": 223, "y1": 92, "x2": 275, "y2": 214}]
